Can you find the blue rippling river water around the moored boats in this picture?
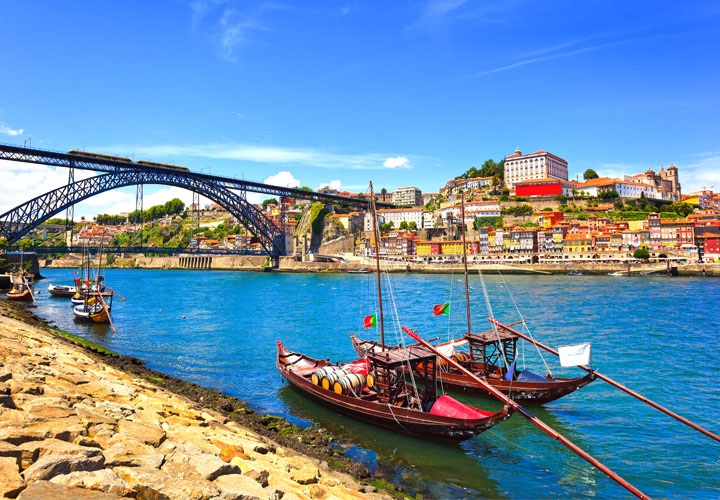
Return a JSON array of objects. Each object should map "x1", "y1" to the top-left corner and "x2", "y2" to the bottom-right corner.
[{"x1": 26, "y1": 269, "x2": 720, "y2": 499}]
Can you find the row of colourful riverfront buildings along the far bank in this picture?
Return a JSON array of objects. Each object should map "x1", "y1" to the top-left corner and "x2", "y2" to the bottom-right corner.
[{"x1": 356, "y1": 211, "x2": 720, "y2": 263}]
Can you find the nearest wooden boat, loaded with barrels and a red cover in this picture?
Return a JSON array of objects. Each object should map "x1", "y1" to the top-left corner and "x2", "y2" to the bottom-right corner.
[{"x1": 276, "y1": 342, "x2": 511, "y2": 442}]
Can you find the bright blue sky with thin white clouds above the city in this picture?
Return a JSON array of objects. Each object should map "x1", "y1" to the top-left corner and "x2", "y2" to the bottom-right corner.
[{"x1": 0, "y1": 0, "x2": 720, "y2": 219}]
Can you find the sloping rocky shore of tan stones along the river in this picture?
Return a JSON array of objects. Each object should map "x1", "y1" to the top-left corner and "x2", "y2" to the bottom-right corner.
[{"x1": 0, "y1": 302, "x2": 392, "y2": 500}]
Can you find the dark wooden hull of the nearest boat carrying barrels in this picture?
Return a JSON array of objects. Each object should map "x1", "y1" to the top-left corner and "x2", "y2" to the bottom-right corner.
[{"x1": 277, "y1": 345, "x2": 510, "y2": 442}]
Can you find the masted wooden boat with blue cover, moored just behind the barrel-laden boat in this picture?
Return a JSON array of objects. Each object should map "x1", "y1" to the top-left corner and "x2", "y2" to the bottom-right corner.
[{"x1": 350, "y1": 193, "x2": 595, "y2": 404}]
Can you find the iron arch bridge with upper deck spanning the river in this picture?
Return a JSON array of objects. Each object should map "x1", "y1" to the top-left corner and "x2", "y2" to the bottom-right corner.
[{"x1": 0, "y1": 144, "x2": 392, "y2": 257}]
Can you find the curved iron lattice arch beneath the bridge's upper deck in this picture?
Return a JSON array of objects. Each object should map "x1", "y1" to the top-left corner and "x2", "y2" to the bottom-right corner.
[{"x1": 0, "y1": 169, "x2": 285, "y2": 256}]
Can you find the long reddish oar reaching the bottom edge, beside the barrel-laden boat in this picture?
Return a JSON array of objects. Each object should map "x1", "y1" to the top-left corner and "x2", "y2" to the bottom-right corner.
[{"x1": 402, "y1": 326, "x2": 650, "y2": 498}]
